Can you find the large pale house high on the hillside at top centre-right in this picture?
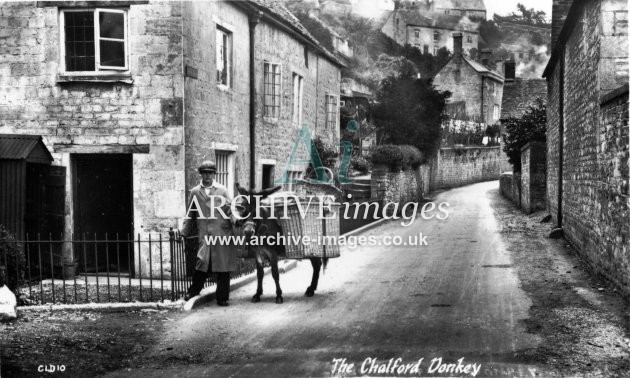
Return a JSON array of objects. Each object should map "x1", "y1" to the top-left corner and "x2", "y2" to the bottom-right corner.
[{"x1": 381, "y1": 9, "x2": 479, "y2": 55}]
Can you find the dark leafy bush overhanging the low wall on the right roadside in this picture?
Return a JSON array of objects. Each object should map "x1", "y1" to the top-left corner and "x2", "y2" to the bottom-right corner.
[{"x1": 501, "y1": 98, "x2": 547, "y2": 172}]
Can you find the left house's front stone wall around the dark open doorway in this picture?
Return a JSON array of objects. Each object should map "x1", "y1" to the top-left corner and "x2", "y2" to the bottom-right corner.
[{"x1": 0, "y1": 2, "x2": 184, "y2": 239}]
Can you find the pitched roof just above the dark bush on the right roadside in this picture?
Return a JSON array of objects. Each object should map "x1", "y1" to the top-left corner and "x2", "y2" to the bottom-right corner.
[{"x1": 501, "y1": 78, "x2": 547, "y2": 119}]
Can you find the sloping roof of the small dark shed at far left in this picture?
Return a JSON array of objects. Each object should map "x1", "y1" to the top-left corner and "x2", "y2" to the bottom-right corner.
[{"x1": 0, "y1": 134, "x2": 53, "y2": 163}]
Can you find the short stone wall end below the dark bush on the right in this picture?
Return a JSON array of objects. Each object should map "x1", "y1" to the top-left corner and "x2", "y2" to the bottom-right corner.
[{"x1": 521, "y1": 142, "x2": 547, "y2": 213}]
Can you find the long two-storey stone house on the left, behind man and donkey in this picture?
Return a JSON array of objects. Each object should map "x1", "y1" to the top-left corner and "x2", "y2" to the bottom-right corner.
[{"x1": 0, "y1": 0, "x2": 341, "y2": 278}]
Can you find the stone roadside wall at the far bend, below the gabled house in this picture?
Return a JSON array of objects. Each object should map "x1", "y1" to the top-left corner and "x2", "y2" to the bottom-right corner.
[{"x1": 431, "y1": 147, "x2": 505, "y2": 189}]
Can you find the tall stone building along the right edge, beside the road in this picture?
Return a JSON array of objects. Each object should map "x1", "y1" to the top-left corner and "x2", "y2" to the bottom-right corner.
[{"x1": 544, "y1": 0, "x2": 630, "y2": 295}]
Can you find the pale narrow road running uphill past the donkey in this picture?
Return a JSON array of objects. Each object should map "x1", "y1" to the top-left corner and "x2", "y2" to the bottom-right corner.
[{"x1": 103, "y1": 181, "x2": 592, "y2": 377}]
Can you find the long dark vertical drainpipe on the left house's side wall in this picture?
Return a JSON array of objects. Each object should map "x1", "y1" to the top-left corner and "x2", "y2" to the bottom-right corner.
[{"x1": 249, "y1": 11, "x2": 262, "y2": 190}]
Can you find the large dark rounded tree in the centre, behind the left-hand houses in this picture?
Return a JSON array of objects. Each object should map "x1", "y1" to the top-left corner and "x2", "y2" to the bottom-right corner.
[{"x1": 374, "y1": 72, "x2": 451, "y2": 156}]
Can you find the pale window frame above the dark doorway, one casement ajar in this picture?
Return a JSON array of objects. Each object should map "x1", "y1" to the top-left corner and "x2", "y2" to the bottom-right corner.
[{"x1": 59, "y1": 7, "x2": 129, "y2": 76}]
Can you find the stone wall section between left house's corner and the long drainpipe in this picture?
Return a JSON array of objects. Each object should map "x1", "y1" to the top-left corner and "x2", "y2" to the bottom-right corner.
[{"x1": 183, "y1": 1, "x2": 250, "y2": 191}]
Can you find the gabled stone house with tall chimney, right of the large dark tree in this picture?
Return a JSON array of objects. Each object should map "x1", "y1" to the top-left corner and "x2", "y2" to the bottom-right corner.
[{"x1": 433, "y1": 33, "x2": 504, "y2": 125}]
